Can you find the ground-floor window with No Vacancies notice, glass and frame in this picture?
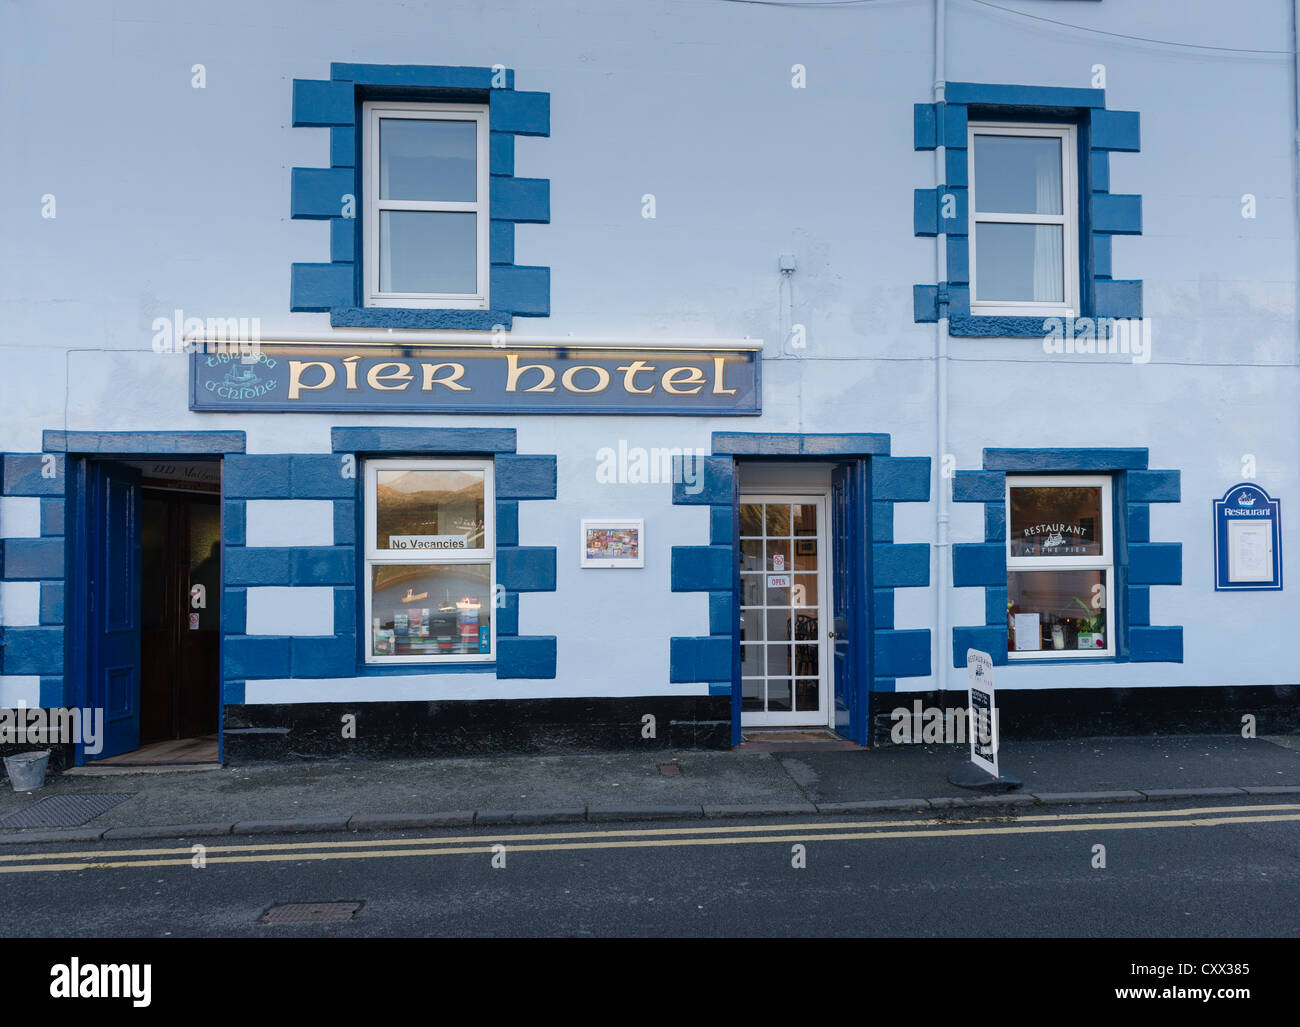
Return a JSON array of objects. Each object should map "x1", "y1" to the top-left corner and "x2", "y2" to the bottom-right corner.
[{"x1": 365, "y1": 460, "x2": 497, "y2": 663}]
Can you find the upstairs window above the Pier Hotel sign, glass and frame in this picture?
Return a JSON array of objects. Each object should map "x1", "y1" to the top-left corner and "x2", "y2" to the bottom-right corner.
[{"x1": 363, "y1": 103, "x2": 490, "y2": 309}]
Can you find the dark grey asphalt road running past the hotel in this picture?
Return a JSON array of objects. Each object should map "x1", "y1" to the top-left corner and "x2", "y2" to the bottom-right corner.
[{"x1": 0, "y1": 800, "x2": 1300, "y2": 937}]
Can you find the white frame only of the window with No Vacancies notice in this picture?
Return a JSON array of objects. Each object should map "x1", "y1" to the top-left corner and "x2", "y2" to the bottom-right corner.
[{"x1": 363, "y1": 459, "x2": 497, "y2": 664}]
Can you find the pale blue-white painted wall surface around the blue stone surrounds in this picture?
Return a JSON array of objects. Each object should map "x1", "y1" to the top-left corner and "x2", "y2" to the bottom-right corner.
[{"x1": 0, "y1": 0, "x2": 1300, "y2": 702}]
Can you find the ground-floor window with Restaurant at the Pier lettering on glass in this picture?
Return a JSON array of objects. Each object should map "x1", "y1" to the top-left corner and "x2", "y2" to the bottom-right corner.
[{"x1": 1006, "y1": 476, "x2": 1115, "y2": 659}]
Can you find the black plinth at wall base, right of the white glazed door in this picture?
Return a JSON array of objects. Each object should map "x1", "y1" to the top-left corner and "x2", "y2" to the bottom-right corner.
[{"x1": 871, "y1": 685, "x2": 1300, "y2": 745}]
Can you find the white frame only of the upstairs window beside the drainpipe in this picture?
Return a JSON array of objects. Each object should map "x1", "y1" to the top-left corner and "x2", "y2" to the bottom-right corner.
[{"x1": 966, "y1": 121, "x2": 1079, "y2": 317}]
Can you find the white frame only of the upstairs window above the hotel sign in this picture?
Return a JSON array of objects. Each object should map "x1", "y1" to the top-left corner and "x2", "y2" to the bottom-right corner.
[{"x1": 361, "y1": 101, "x2": 491, "y2": 309}]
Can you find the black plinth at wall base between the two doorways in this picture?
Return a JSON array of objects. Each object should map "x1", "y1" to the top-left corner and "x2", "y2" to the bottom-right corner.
[{"x1": 224, "y1": 696, "x2": 731, "y2": 763}]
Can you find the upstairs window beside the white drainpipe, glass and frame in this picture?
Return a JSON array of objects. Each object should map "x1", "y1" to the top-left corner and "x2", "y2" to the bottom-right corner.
[{"x1": 967, "y1": 124, "x2": 1079, "y2": 317}]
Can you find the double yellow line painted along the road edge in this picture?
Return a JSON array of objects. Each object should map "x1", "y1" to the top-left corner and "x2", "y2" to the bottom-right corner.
[{"x1": 0, "y1": 803, "x2": 1300, "y2": 874}]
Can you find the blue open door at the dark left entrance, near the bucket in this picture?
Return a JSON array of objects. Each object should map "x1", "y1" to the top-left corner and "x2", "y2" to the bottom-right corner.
[{"x1": 78, "y1": 462, "x2": 140, "y2": 759}]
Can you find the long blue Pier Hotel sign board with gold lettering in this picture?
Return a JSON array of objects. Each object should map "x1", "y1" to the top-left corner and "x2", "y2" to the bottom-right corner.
[{"x1": 190, "y1": 342, "x2": 762, "y2": 416}]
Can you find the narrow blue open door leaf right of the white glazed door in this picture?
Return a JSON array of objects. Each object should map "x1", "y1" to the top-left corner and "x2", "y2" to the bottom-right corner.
[{"x1": 831, "y1": 460, "x2": 871, "y2": 745}]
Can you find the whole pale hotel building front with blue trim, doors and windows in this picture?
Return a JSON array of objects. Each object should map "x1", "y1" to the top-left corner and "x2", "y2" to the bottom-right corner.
[{"x1": 0, "y1": 0, "x2": 1300, "y2": 762}]
